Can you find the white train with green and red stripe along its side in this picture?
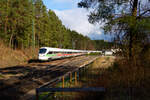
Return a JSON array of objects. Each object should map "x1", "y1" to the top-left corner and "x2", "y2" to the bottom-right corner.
[{"x1": 38, "y1": 47, "x2": 101, "y2": 61}]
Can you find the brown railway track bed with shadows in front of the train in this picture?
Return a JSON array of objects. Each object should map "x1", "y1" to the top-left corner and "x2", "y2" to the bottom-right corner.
[{"x1": 0, "y1": 56, "x2": 98, "y2": 100}]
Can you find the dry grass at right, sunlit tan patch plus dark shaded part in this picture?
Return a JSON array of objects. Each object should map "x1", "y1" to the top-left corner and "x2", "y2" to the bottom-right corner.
[{"x1": 72, "y1": 57, "x2": 150, "y2": 100}]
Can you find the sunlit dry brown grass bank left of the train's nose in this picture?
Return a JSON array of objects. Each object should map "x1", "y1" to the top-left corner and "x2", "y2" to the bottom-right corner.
[{"x1": 0, "y1": 42, "x2": 38, "y2": 68}]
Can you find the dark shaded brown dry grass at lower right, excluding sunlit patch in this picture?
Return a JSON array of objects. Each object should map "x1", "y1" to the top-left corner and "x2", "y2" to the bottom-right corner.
[{"x1": 86, "y1": 59, "x2": 150, "y2": 100}]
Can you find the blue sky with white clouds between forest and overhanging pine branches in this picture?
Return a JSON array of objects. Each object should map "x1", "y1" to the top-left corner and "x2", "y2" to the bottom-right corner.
[{"x1": 43, "y1": 0, "x2": 111, "y2": 40}]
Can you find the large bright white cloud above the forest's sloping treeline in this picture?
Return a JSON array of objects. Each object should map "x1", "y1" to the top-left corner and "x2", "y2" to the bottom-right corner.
[{"x1": 54, "y1": 8, "x2": 102, "y2": 36}]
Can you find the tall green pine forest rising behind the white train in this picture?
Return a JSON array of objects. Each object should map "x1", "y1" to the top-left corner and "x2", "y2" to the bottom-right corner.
[{"x1": 0, "y1": 0, "x2": 112, "y2": 50}]
